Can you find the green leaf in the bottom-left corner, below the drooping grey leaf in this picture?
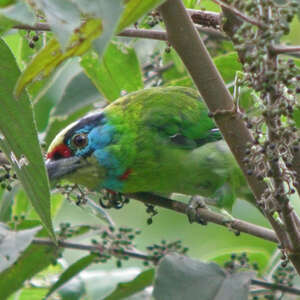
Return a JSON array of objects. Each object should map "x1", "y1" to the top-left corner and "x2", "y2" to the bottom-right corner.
[{"x1": 0, "y1": 221, "x2": 60, "y2": 300}]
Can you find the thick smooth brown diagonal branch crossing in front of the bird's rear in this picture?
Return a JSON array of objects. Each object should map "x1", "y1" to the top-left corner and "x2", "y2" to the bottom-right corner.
[{"x1": 160, "y1": 0, "x2": 266, "y2": 206}]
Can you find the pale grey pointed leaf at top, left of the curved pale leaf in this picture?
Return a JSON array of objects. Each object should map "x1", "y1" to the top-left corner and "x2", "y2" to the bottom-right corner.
[{"x1": 33, "y1": 0, "x2": 81, "y2": 48}]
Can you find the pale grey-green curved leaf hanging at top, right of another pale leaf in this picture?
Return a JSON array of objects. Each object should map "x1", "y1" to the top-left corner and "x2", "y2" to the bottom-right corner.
[{"x1": 73, "y1": 0, "x2": 124, "y2": 57}]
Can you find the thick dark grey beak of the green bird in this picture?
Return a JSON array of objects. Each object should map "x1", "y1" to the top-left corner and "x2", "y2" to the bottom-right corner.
[{"x1": 46, "y1": 156, "x2": 85, "y2": 181}]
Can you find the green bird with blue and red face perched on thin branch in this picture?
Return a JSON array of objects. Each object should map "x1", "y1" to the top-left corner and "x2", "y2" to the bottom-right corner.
[{"x1": 46, "y1": 87, "x2": 253, "y2": 209}]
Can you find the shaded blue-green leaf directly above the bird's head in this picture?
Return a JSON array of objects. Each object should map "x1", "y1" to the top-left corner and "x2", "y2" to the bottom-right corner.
[{"x1": 52, "y1": 72, "x2": 105, "y2": 116}]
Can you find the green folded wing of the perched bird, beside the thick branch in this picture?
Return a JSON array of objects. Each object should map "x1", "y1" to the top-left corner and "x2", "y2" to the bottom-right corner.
[{"x1": 139, "y1": 87, "x2": 222, "y2": 149}]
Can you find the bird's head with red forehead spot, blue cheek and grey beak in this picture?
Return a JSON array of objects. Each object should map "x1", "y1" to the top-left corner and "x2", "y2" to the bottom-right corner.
[{"x1": 46, "y1": 112, "x2": 109, "y2": 189}]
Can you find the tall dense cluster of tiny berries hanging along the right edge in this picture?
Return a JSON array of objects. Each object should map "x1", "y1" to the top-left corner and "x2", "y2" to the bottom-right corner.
[{"x1": 226, "y1": 0, "x2": 300, "y2": 213}]
